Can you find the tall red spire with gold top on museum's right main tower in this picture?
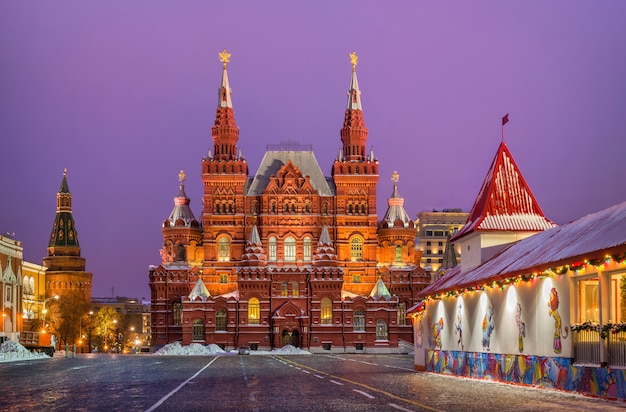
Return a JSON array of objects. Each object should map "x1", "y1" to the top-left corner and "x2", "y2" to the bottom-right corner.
[{"x1": 341, "y1": 52, "x2": 368, "y2": 162}]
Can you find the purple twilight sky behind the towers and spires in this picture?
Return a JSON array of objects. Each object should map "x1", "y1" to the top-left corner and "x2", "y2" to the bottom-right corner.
[{"x1": 0, "y1": 0, "x2": 626, "y2": 297}]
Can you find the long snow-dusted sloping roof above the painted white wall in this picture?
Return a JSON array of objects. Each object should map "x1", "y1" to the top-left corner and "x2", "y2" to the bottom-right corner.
[{"x1": 419, "y1": 202, "x2": 626, "y2": 297}]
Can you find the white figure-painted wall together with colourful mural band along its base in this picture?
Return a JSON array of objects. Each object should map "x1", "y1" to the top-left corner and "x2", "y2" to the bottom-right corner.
[{"x1": 414, "y1": 276, "x2": 626, "y2": 399}]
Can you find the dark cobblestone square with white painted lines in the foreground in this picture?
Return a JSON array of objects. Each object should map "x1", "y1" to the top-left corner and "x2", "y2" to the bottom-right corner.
[{"x1": 0, "y1": 354, "x2": 626, "y2": 412}]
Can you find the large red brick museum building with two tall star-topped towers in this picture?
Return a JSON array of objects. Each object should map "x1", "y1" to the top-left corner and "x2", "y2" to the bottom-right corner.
[{"x1": 149, "y1": 51, "x2": 430, "y2": 353}]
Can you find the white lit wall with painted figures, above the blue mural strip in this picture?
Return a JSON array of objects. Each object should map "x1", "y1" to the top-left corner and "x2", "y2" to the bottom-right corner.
[{"x1": 416, "y1": 277, "x2": 573, "y2": 358}]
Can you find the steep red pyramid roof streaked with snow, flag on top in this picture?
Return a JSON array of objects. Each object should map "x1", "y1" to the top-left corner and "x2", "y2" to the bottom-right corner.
[{"x1": 451, "y1": 142, "x2": 556, "y2": 242}]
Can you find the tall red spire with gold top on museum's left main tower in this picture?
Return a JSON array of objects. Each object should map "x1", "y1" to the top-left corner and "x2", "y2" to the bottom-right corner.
[{"x1": 211, "y1": 50, "x2": 239, "y2": 160}]
